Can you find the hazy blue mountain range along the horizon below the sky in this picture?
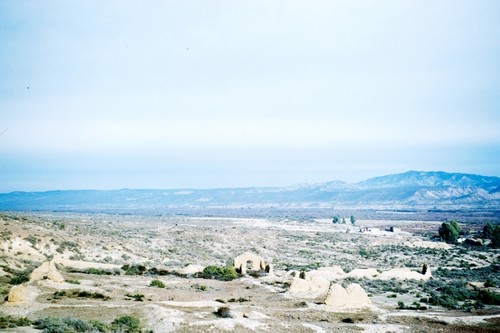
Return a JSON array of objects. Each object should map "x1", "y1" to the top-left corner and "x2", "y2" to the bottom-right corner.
[{"x1": 0, "y1": 171, "x2": 500, "y2": 212}]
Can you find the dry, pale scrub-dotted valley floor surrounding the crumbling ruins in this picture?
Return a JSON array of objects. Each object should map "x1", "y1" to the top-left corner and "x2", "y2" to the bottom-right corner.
[{"x1": 0, "y1": 213, "x2": 500, "y2": 333}]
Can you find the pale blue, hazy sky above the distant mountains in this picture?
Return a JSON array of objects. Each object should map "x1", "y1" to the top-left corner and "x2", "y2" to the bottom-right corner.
[{"x1": 0, "y1": 0, "x2": 500, "y2": 192}]
